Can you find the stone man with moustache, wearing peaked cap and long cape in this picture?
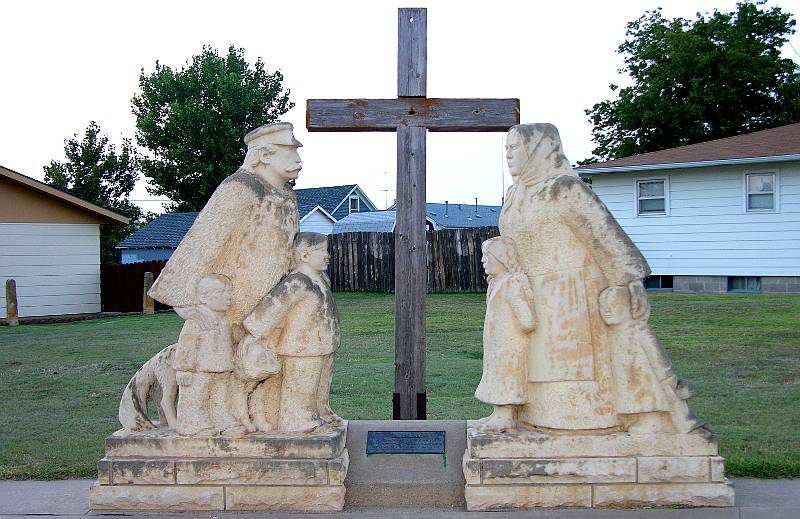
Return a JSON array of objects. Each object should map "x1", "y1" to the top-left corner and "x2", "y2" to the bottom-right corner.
[{"x1": 150, "y1": 122, "x2": 302, "y2": 342}]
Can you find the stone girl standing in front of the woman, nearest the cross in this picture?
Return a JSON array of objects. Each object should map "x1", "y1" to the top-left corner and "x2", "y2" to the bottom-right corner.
[{"x1": 475, "y1": 236, "x2": 535, "y2": 432}]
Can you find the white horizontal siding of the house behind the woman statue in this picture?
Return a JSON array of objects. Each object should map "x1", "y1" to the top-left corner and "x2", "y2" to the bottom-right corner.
[{"x1": 592, "y1": 162, "x2": 800, "y2": 276}]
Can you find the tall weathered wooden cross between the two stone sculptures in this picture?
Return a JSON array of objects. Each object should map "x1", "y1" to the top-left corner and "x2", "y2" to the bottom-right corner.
[{"x1": 306, "y1": 9, "x2": 519, "y2": 420}]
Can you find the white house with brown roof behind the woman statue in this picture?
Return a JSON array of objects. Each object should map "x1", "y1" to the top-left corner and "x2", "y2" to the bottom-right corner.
[{"x1": 577, "y1": 124, "x2": 800, "y2": 293}]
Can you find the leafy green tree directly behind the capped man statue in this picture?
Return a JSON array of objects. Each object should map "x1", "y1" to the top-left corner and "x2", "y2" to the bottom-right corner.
[{"x1": 133, "y1": 46, "x2": 294, "y2": 211}]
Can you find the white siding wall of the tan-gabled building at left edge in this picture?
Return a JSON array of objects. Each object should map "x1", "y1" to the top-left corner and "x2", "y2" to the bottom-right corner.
[{"x1": 0, "y1": 223, "x2": 100, "y2": 318}]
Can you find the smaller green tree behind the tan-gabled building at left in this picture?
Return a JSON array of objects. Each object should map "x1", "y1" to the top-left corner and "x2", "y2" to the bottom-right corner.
[{"x1": 44, "y1": 121, "x2": 143, "y2": 265}]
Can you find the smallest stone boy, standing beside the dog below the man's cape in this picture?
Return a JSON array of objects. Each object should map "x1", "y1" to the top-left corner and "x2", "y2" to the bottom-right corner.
[{"x1": 173, "y1": 274, "x2": 244, "y2": 436}]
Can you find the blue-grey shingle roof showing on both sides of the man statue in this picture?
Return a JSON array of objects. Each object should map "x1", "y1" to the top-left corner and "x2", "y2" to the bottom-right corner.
[{"x1": 117, "y1": 184, "x2": 356, "y2": 249}]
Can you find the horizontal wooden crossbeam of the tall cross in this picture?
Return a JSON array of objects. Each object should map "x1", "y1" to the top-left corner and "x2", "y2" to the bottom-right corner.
[{"x1": 306, "y1": 97, "x2": 519, "y2": 132}]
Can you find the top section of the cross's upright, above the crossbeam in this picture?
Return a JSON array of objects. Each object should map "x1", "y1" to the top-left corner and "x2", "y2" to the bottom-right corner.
[{"x1": 397, "y1": 9, "x2": 428, "y2": 97}]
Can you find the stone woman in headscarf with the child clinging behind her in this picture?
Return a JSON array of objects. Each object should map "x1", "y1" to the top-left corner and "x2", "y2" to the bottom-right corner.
[{"x1": 500, "y1": 124, "x2": 701, "y2": 433}]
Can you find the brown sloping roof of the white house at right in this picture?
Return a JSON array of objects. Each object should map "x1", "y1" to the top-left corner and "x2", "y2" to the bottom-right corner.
[{"x1": 575, "y1": 123, "x2": 800, "y2": 174}]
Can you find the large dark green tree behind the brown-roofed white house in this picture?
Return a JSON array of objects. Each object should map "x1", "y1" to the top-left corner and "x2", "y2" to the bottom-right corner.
[{"x1": 584, "y1": 1, "x2": 800, "y2": 163}]
